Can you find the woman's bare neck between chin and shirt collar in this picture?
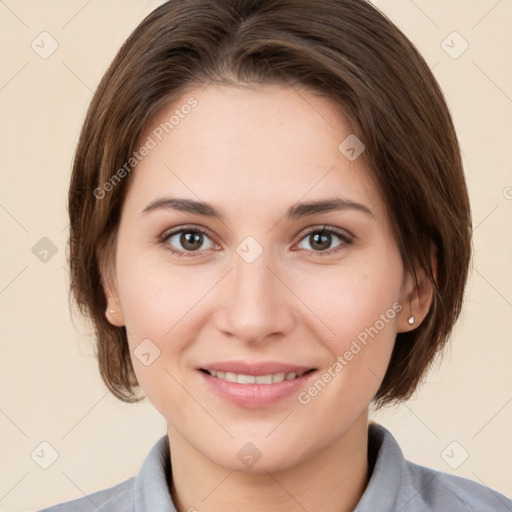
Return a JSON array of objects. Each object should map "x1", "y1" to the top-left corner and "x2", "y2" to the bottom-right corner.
[{"x1": 168, "y1": 410, "x2": 369, "y2": 512}]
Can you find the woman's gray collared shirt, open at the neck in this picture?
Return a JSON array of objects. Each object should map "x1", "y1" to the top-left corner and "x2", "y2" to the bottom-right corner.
[{"x1": 40, "y1": 422, "x2": 512, "y2": 512}]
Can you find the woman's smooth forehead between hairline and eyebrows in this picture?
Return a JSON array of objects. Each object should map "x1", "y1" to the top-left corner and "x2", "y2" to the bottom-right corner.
[{"x1": 128, "y1": 84, "x2": 380, "y2": 219}]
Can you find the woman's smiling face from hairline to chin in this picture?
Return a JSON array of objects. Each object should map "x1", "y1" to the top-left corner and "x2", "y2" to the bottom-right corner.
[{"x1": 107, "y1": 85, "x2": 410, "y2": 471}]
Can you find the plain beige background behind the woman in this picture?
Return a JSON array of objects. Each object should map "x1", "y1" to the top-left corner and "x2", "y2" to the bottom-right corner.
[{"x1": 0, "y1": 0, "x2": 512, "y2": 511}]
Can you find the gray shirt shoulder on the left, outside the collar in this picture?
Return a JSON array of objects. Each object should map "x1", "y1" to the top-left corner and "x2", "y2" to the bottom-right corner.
[{"x1": 39, "y1": 477, "x2": 135, "y2": 512}]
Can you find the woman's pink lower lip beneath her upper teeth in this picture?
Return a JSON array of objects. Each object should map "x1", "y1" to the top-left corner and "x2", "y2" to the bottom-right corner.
[{"x1": 199, "y1": 371, "x2": 316, "y2": 409}]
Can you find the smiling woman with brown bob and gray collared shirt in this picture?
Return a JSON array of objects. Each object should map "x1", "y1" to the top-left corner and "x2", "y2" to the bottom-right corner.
[{"x1": 39, "y1": 0, "x2": 512, "y2": 512}]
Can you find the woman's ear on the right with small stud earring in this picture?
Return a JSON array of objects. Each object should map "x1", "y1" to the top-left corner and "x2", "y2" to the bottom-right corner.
[{"x1": 397, "y1": 244, "x2": 437, "y2": 332}]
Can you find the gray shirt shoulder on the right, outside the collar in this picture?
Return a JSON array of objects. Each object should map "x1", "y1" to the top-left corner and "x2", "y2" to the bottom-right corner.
[{"x1": 406, "y1": 461, "x2": 512, "y2": 512}]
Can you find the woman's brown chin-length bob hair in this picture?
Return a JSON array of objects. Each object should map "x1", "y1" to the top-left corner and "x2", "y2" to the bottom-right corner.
[{"x1": 67, "y1": 0, "x2": 472, "y2": 408}]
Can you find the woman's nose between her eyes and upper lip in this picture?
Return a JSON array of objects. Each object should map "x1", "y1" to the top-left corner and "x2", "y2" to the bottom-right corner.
[{"x1": 216, "y1": 251, "x2": 297, "y2": 344}]
